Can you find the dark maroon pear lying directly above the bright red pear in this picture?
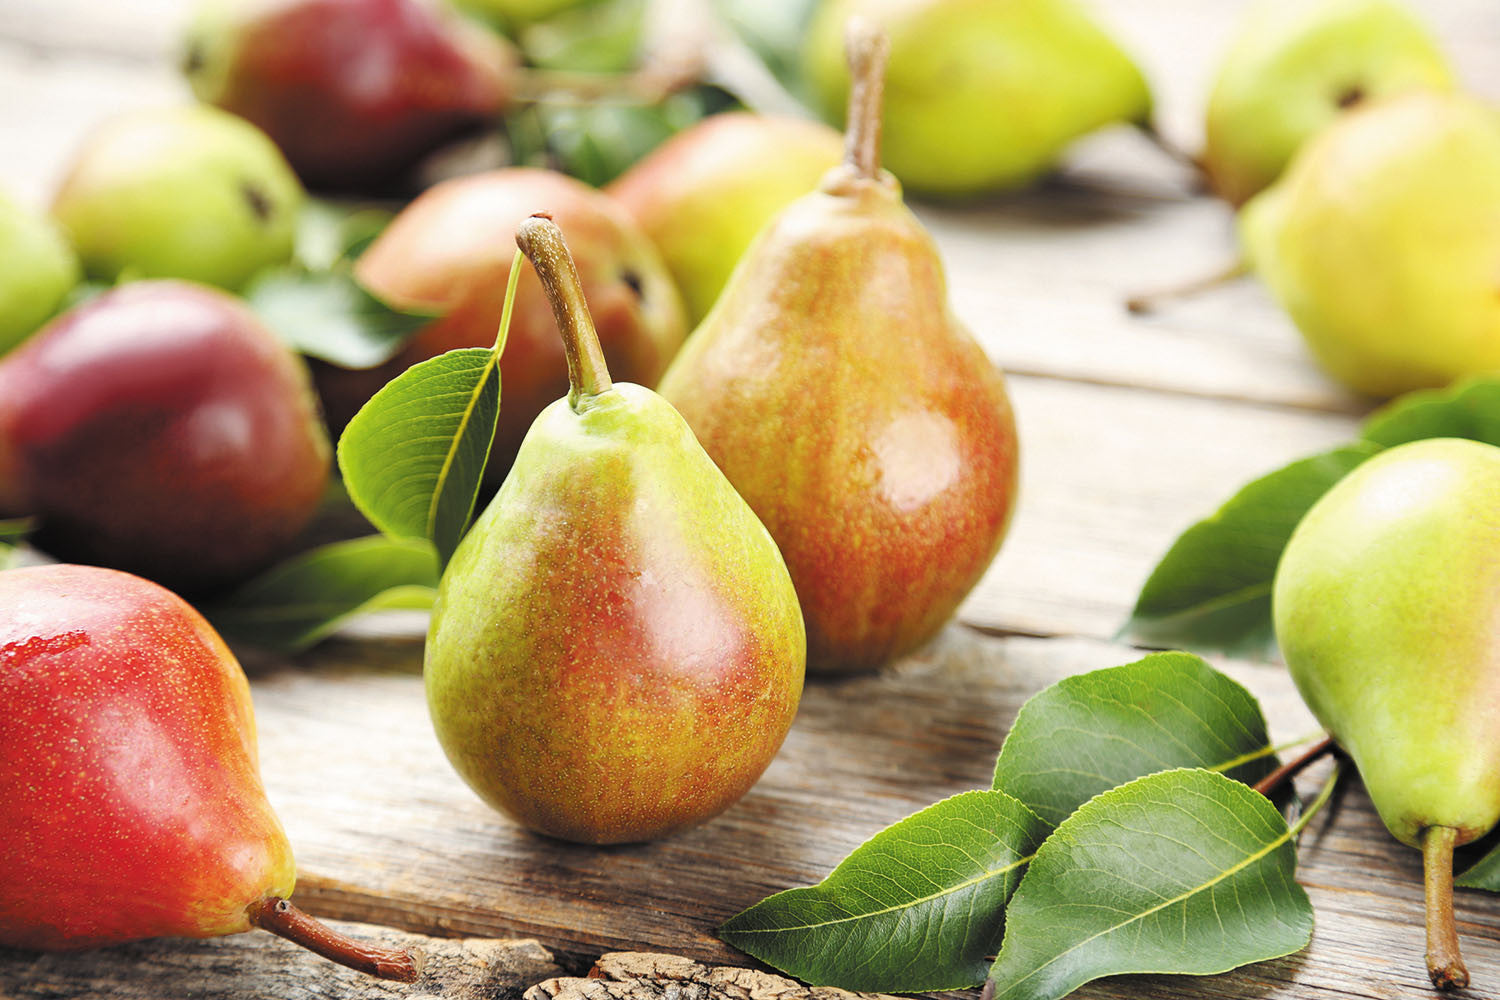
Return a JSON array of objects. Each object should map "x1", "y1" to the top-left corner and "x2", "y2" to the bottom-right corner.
[{"x1": 0, "y1": 282, "x2": 332, "y2": 591}]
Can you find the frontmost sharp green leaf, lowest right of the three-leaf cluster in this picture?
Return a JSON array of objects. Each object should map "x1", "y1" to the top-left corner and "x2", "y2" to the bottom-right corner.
[{"x1": 990, "y1": 769, "x2": 1313, "y2": 1000}]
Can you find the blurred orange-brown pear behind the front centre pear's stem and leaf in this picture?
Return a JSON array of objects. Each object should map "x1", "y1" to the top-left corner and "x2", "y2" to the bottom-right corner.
[{"x1": 325, "y1": 168, "x2": 687, "y2": 483}]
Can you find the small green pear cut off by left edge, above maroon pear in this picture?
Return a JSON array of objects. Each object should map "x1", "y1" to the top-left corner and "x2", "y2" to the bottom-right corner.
[{"x1": 0, "y1": 193, "x2": 80, "y2": 354}]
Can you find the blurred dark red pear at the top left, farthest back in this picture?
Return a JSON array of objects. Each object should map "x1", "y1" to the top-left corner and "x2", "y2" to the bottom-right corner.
[{"x1": 185, "y1": 0, "x2": 518, "y2": 190}]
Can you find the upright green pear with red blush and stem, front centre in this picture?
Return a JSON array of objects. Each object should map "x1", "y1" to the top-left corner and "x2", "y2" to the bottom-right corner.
[{"x1": 423, "y1": 217, "x2": 806, "y2": 844}]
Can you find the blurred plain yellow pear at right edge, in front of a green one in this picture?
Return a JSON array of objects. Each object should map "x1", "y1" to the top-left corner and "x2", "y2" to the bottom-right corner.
[{"x1": 1239, "y1": 93, "x2": 1500, "y2": 396}]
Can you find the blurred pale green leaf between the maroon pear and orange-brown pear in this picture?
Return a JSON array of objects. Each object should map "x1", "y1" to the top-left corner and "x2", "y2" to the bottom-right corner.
[{"x1": 245, "y1": 265, "x2": 432, "y2": 369}]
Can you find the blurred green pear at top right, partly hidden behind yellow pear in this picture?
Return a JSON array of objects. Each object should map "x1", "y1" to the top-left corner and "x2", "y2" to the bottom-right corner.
[{"x1": 1200, "y1": 0, "x2": 1455, "y2": 205}]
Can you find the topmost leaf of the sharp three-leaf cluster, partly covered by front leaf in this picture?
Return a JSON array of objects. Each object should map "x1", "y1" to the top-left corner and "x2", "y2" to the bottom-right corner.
[{"x1": 995, "y1": 652, "x2": 1278, "y2": 826}]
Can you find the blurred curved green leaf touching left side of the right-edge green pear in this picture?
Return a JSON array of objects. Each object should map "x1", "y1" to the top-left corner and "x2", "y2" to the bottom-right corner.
[{"x1": 1121, "y1": 442, "x2": 1380, "y2": 657}]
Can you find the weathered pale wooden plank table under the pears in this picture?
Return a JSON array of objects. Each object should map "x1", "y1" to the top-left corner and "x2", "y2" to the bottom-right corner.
[{"x1": 0, "y1": 0, "x2": 1500, "y2": 999}]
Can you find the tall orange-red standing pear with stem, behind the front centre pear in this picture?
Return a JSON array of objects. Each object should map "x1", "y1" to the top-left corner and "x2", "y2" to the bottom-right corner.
[{"x1": 662, "y1": 21, "x2": 1017, "y2": 672}]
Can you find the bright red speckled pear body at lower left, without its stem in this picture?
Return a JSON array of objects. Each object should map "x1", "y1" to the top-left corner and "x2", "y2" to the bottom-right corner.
[{"x1": 0, "y1": 565, "x2": 296, "y2": 951}]
